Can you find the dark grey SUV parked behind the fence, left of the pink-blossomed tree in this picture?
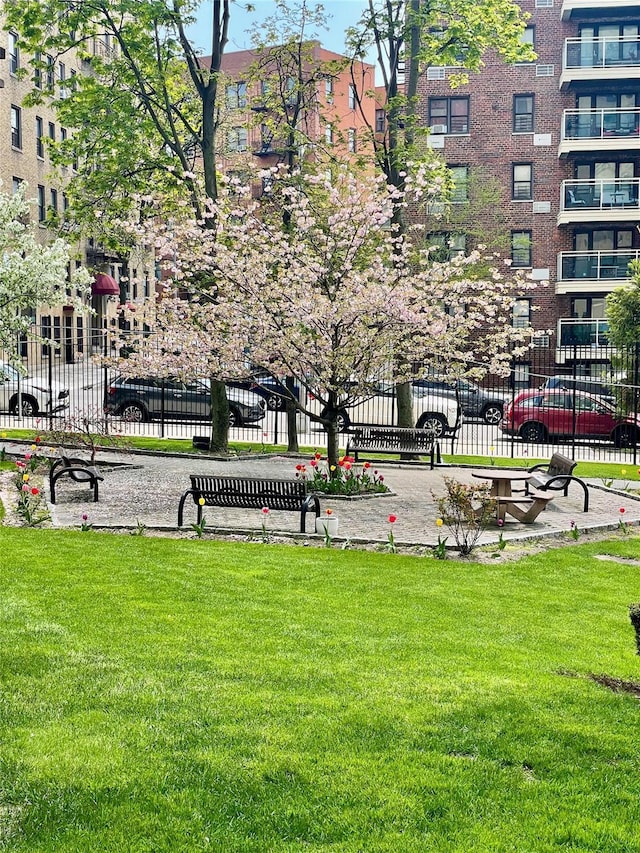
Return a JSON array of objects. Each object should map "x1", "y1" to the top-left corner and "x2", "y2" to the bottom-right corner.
[{"x1": 105, "y1": 376, "x2": 266, "y2": 427}]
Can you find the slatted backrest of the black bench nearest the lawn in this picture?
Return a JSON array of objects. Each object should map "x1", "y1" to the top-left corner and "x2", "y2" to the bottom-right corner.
[{"x1": 191, "y1": 474, "x2": 307, "y2": 509}]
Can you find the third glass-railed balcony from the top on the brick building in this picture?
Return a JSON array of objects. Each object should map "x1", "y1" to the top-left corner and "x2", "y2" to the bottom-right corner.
[{"x1": 558, "y1": 178, "x2": 640, "y2": 225}]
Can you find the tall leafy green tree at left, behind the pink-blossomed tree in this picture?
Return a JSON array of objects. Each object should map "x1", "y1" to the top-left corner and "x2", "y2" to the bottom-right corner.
[{"x1": 4, "y1": 0, "x2": 231, "y2": 450}]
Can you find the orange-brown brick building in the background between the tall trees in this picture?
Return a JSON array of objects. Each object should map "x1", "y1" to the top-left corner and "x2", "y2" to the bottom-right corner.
[{"x1": 212, "y1": 41, "x2": 376, "y2": 192}]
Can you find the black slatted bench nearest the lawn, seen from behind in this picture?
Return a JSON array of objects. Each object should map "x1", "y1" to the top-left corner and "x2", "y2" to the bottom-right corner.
[{"x1": 178, "y1": 474, "x2": 320, "y2": 533}]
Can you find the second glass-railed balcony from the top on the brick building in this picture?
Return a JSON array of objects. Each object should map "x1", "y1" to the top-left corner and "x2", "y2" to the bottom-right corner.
[{"x1": 558, "y1": 107, "x2": 640, "y2": 157}]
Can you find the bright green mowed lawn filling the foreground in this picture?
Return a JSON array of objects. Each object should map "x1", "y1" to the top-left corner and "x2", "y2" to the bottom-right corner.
[{"x1": 0, "y1": 528, "x2": 640, "y2": 853}]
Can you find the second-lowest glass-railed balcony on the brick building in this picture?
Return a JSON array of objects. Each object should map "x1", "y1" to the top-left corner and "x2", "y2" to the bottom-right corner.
[{"x1": 556, "y1": 249, "x2": 640, "y2": 294}]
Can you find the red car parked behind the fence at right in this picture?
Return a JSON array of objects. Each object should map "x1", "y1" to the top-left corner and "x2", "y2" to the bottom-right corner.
[{"x1": 500, "y1": 390, "x2": 640, "y2": 447}]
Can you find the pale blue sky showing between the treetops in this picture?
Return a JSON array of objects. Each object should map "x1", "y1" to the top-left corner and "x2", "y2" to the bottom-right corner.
[{"x1": 190, "y1": 0, "x2": 367, "y2": 54}]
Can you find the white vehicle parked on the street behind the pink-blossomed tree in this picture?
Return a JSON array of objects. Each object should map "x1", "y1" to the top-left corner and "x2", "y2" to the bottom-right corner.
[{"x1": 311, "y1": 382, "x2": 461, "y2": 438}]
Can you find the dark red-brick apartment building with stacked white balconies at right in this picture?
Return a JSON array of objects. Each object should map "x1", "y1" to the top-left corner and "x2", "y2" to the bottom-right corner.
[{"x1": 420, "y1": 0, "x2": 640, "y2": 385}]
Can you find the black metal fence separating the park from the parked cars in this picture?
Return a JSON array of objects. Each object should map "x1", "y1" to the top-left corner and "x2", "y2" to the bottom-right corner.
[{"x1": 0, "y1": 341, "x2": 640, "y2": 465}]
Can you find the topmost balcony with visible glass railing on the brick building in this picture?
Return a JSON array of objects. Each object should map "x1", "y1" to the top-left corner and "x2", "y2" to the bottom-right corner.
[{"x1": 560, "y1": 36, "x2": 640, "y2": 90}]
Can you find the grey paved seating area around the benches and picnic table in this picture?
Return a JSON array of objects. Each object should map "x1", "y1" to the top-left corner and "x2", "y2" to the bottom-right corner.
[{"x1": 16, "y1": 446, "x2": 640, "y2": 547}]
